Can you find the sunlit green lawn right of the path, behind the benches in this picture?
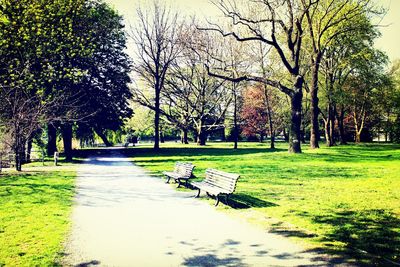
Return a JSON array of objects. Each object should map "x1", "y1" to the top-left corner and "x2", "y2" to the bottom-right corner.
[{"x1": 126, "y1": 143, "x2": 400, "y2": 265}]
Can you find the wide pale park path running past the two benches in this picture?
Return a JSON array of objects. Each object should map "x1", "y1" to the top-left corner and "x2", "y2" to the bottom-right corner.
[{"x1": 63, "y1": 150, "x2": 326, "y2": 267}]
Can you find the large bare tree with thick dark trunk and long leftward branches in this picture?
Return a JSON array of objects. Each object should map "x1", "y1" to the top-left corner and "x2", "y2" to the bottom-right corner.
[{"x1": 199, "y1": 0, "x2": 311, "y2": 153}]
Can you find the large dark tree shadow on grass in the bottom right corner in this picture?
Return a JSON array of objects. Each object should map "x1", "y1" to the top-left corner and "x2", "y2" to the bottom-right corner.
[{"x1": 260, "y1": 210, "x2": 400, "y2": 266}]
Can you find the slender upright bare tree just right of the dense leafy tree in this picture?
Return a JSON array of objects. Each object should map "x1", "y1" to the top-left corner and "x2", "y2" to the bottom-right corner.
[{"x1": 131, "y1": 2, "x2": 182, "y2": 150}]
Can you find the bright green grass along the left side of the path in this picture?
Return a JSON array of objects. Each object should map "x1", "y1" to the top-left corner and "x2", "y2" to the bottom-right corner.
[{"x1": 0, "y1": 164, "x2": 76, "y2": 266}]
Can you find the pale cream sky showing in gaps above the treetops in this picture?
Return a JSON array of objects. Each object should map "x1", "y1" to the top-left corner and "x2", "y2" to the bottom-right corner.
[{"x1": 106, "y1": 0, "x2": 400, "y2": 61}]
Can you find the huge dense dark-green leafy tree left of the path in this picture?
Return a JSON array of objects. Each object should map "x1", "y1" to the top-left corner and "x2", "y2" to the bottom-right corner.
[{"x1": 0, "y1": 0, "x2": 130, "y2": 166}]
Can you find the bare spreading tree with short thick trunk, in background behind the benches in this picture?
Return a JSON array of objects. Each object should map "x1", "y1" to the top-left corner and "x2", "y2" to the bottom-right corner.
[{"x1": 163, "y1": 31, "x2": 232, "y2": 145}]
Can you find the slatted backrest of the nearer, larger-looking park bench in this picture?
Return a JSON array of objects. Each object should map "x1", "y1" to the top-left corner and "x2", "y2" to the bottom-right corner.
[{"x1": 204, "y1": 169, "x2": 240, "y2": 194}]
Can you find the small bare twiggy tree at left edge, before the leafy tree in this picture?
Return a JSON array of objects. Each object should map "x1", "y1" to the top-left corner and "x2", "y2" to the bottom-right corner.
[{"x1": 0, "y1": 68, "x2": 81, "y2": 171}]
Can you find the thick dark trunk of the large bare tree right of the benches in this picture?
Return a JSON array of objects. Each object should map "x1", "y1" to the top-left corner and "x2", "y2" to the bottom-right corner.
[{"x1": 289, "y1": 76, "x2": 304, "y2": 153}]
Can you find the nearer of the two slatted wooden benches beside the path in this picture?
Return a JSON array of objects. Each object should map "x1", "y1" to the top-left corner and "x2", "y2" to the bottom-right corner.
[{"x1": 191, "y1": 169, "x2": 240, "y2": 206}]
